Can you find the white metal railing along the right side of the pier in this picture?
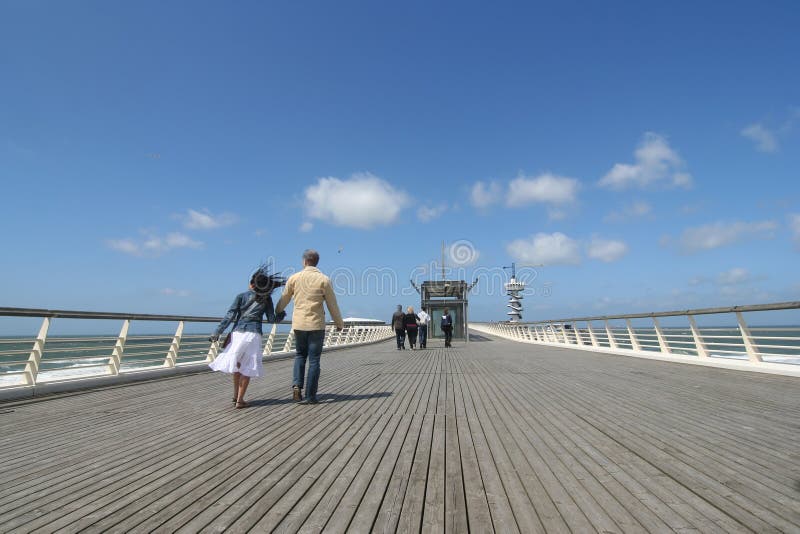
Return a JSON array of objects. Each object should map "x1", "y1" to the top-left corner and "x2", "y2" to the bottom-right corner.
[{"x1": 470, "y1": 302, "x2": 800, "y2": 374}]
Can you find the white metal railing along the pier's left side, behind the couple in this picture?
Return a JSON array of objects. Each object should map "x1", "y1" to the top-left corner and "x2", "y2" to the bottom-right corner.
[{"x1": 0, "y1": 308, "x2": 394, "y2": 391}]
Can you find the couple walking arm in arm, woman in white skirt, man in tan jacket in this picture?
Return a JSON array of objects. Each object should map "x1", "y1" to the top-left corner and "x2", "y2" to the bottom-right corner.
[{"x1": 209, "y1": 249, "x2": 344, "y2": 408}]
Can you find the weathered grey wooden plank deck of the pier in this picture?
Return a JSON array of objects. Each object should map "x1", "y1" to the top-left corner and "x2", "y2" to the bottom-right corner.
[{"x1": 0, "y1": 336, "x2": 800, "y2": 533}]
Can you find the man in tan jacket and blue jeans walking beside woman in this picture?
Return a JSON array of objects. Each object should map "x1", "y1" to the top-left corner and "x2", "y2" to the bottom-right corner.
[{"x1": 275, "y1": 249, "x2": 344, "y2": 404}]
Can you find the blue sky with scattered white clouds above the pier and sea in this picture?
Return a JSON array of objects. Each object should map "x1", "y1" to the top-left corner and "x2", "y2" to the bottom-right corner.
[{"x1": 0, "y1": 1, "x2": 800, "y2": 326}]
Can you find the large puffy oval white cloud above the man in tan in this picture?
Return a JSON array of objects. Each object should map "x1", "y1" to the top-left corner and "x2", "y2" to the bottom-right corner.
[{"x1": 305, "y1": 173, "x2": 410, "y2": 230}]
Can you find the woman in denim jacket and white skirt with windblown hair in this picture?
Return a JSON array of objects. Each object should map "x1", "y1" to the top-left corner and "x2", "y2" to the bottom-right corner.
[{"x1": 209, "y1": 267, "x2": 286, "y2": 408}]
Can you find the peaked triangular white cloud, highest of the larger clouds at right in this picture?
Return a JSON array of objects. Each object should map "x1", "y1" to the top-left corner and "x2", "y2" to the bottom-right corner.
[{"x1": 599, "y1": 132, "x2": 692, "y2": 189}]
